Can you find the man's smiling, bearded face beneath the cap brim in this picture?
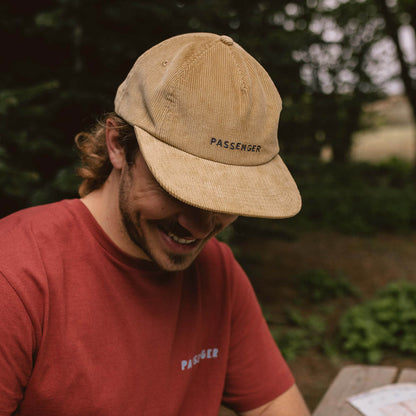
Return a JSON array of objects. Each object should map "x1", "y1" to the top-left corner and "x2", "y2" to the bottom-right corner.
[{"x1": 119, "y1": 154, "x2": 237, "y2": 271}]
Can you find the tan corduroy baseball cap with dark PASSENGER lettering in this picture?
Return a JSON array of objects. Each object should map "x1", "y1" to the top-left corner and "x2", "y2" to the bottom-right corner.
[{"x1": 115, "y1": 33, "x2": 301, "y2": 218}]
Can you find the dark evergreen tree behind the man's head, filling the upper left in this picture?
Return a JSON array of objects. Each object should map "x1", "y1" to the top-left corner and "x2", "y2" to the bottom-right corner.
[{"x1": 0, "y1": 0, "x2": 316, "y2": 216}]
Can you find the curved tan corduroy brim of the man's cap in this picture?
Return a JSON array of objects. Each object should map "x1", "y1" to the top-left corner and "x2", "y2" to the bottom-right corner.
[{"x1": 134, "y1": 126, "x2": 302, "y2": 218}]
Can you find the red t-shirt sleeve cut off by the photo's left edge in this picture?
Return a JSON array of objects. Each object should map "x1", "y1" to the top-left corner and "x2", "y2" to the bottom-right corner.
[{"x1": 0, "y1": 273, "x2": 35, "y2": 416}]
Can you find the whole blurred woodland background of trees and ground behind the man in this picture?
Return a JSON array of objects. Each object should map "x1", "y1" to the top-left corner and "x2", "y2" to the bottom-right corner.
[{"x1": 0, "y1": 0, "x2": 416, "y2": 408}]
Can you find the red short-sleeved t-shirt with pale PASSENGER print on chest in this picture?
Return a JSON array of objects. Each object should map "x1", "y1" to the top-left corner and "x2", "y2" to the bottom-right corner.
[{"x1": 0, "y1": 200, "x2": 293, "y2": 416}]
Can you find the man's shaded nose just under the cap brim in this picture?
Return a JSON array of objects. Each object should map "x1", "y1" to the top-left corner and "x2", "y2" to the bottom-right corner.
[{"x1": 178, "y1": 205, "x2": 217, "y2": 240}]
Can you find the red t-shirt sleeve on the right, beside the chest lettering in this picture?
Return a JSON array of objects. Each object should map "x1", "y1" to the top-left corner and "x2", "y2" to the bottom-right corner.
[{"x1": 219, "y1": 245, "x2": 294, "y2": 412}]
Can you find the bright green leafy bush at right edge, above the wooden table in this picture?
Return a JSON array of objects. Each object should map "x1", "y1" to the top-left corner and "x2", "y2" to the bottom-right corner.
[{"x1": 339, "y1": 281, "x2": 416, "y2": 364}]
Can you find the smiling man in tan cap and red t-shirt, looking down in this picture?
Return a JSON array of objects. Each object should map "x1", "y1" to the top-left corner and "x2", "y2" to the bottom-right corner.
[{"x1": 0, "y1": 33, "x2": 309, "y2": 416}]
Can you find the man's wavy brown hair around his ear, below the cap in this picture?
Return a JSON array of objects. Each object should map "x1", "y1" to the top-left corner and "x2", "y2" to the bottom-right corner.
[{"x1": 75, "y1": 112, "x2": 139, "y2": 197}]
